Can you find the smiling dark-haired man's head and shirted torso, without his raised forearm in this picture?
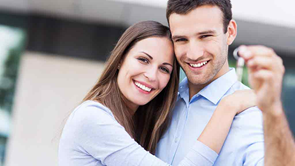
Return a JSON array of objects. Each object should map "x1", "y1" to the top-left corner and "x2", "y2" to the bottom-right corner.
[{"x1": 156, "y1": 0, "x2": 264, "y2": 166}]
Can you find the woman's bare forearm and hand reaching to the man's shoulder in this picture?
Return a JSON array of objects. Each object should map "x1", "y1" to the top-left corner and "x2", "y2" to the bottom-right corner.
[{"x1": 198, "y1": 90, "x2": 256, "y2": 153}]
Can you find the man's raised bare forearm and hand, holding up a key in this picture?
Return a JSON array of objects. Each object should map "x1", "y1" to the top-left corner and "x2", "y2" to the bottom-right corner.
[{"x1": 239, "y1": 46, "x2": 295, "y2": 166}]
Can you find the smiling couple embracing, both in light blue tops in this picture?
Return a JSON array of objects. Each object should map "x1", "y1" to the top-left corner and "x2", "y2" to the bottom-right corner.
[{"x1": 59, "y1": 0, "x2": 292, "y2": 166}]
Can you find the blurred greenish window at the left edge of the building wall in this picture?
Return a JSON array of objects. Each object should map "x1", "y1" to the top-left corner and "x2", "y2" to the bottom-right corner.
[{"x1": 0, "y1": 25, "x2": 25, "y2": 166}]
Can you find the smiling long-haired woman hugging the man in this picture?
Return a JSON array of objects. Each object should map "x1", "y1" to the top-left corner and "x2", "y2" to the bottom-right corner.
[{"x1": 59, "y1": 21, "x2": 254, "y2": 166}]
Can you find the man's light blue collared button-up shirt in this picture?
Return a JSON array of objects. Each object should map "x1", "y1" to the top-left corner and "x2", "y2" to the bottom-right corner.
[{"x1": 156, "y1": 69, "x2": 264, "y2": 166}]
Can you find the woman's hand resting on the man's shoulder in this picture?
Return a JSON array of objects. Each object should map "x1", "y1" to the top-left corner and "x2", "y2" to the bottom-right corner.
[{"x1": 220, "y1": 90, "x2": 256, "y2": 115}]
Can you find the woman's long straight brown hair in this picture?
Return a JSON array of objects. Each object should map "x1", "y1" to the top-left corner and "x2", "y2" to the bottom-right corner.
[{"x1": 83, "y1": 21, "x2": 179, "y2": 154}]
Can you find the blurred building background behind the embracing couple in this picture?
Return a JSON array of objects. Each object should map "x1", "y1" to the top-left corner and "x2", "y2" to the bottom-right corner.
[{"x1": 0, "y1": 0, "x2": 295, "y2": 166}]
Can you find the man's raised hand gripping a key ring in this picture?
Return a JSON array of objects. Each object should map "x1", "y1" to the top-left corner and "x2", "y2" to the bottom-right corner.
[{"x1": 239, "y1": 46, "x2": 285, "y2": 114}]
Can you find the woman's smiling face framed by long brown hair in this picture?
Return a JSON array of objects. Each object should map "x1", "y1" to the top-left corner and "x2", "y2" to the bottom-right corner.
[{"x1": 117, "y1": 37, "x2": 174, "y2": 111}]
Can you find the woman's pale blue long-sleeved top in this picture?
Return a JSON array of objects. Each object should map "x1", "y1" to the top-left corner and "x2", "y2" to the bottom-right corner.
[{"x1": 58, "y1": 101, "x2": 222, "y2": 166}]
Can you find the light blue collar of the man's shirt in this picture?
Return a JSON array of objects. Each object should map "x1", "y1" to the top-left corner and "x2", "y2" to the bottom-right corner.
[{"x1": 179, "y1": 68, "x2": 237, "y2": 104}]
